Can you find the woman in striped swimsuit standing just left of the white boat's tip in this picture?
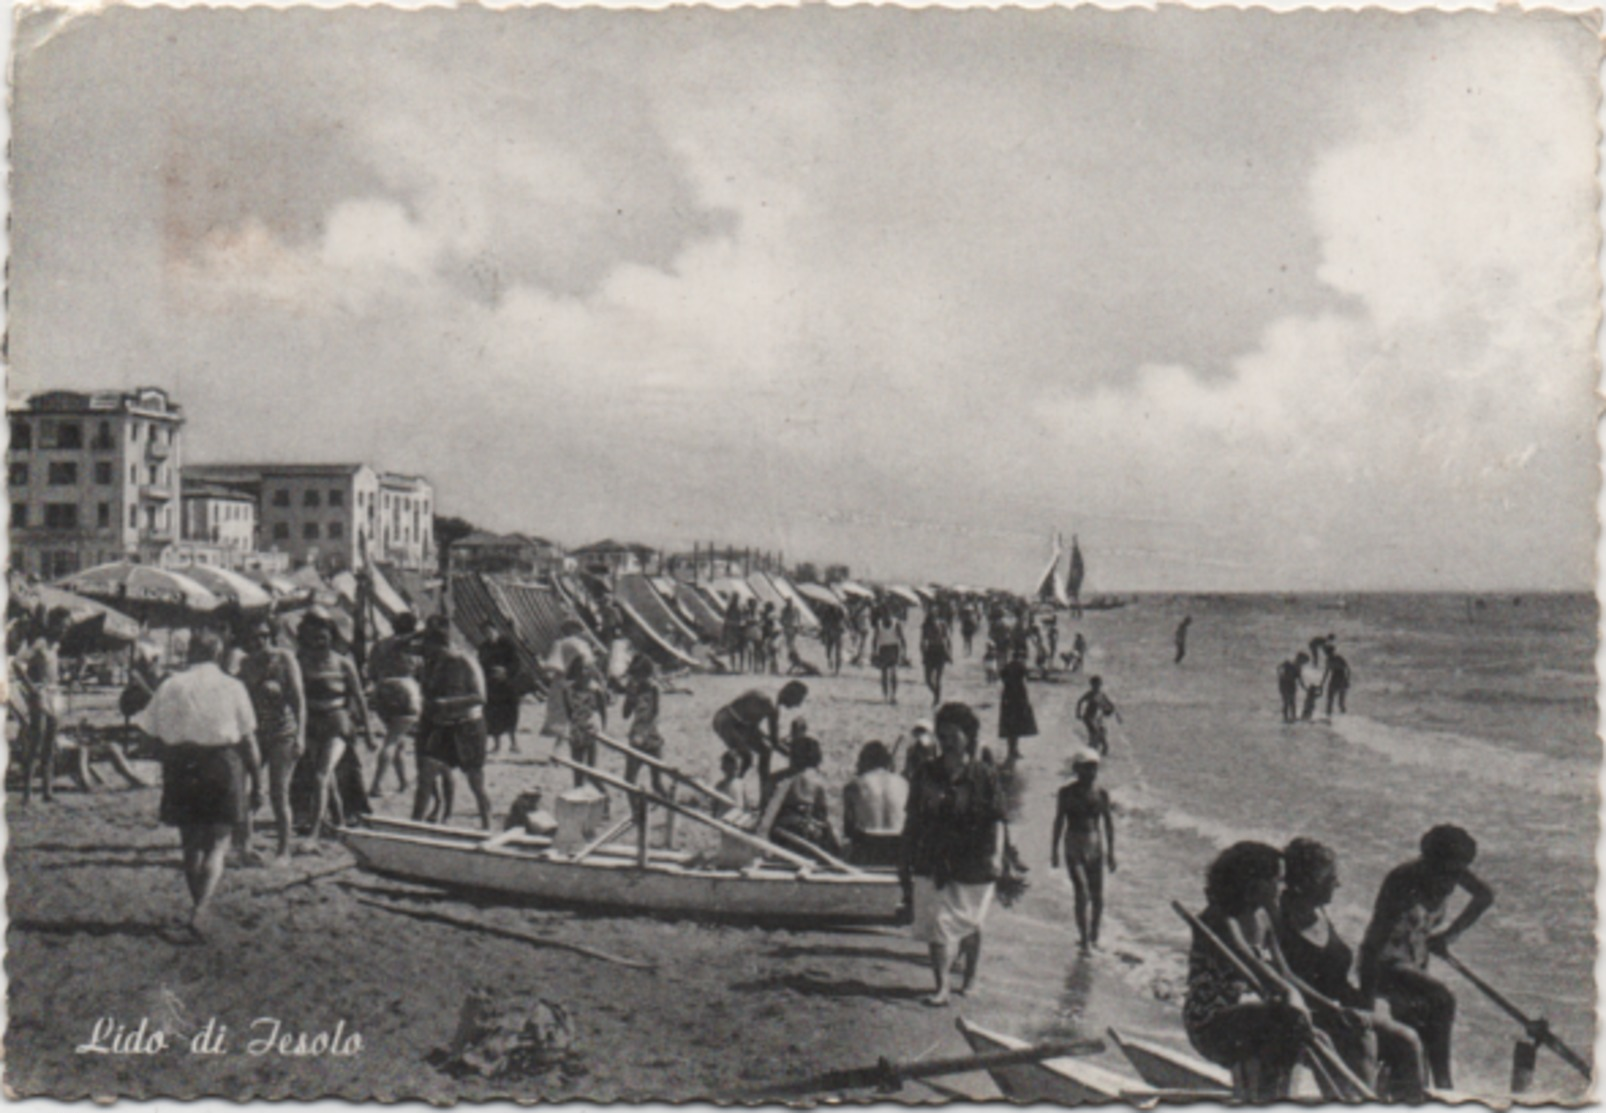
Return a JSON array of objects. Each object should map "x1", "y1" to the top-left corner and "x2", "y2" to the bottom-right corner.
[{"x1": 291, "y1": 607, "x2": 379, "y2": 854}]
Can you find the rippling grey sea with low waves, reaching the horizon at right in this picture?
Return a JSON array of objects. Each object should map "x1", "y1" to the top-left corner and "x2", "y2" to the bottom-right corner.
[{"x1": 972, "y1": 594, "x2": 1601, "y2": 1102}]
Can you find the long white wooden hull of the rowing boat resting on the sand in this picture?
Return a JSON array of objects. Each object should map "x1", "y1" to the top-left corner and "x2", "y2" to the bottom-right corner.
[{"x1": 342, "y1": 817, "x2": 903, "y2": 923}]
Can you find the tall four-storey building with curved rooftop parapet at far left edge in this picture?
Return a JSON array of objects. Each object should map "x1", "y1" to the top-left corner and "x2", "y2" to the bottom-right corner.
[{"x1": 6, "y1": 387, "x2": 185, "y2": 580}]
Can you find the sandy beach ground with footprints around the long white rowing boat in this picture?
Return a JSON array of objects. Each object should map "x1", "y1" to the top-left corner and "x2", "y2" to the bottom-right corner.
[{"x1": 6, "y1": 646, "x2": 1166, "y2": 1102}]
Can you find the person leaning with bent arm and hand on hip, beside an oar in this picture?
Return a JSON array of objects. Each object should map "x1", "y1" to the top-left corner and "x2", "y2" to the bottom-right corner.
[{"x1": 1360, "y1": 824, "x2": 1495, "y2": 1091}]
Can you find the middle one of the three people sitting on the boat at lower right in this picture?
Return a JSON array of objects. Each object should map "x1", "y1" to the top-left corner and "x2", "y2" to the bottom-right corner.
[{"x1": 1277, "y1": 838, "x2": 1426, "y2": 1105}]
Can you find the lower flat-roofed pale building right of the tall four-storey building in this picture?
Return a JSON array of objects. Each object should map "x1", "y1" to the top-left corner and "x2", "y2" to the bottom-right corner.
[{"x1": 188, "y1": 464, "x2": 435, "y2": 572}]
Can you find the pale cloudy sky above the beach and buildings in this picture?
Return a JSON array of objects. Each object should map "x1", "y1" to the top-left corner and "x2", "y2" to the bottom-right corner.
[{"x1": 10, "y1": 6, "x2": 1600, "y2": 593}]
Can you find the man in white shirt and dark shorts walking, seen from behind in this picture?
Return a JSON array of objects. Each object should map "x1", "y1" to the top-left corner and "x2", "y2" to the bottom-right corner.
[{"x1": 138, "y1": 630, "x2": 262, "y2": 940}]
